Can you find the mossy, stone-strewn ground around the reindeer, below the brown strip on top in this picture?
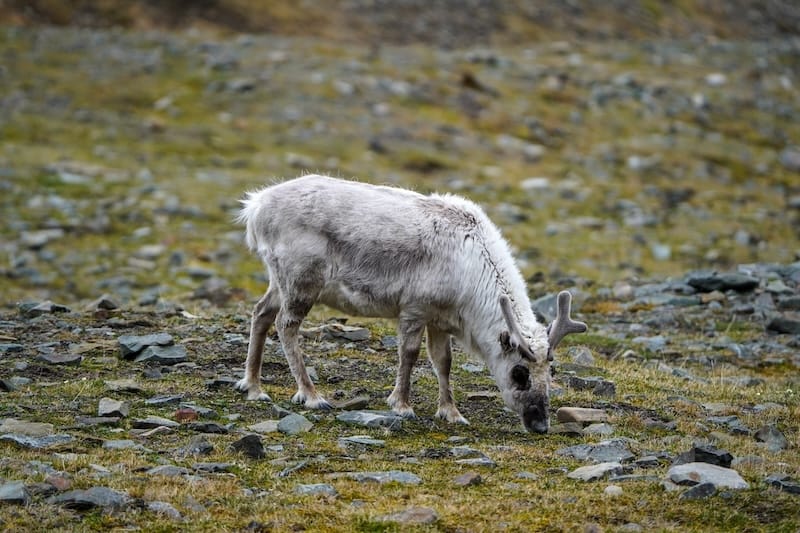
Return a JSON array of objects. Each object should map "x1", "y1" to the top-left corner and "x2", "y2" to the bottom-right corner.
[{"x1": 0, "y1": 18, "x2": 800, "y2": 531}]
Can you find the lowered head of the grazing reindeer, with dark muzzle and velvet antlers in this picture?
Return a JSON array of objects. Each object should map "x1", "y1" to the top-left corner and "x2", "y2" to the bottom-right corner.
[{"x1": 495, "y1": 291, "x2": 586, "y2": 433}]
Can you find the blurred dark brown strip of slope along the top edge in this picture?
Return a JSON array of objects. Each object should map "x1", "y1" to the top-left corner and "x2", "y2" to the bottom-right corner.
[{"x1": 0, "y1": 0, "x2": 800, "y2": 46}]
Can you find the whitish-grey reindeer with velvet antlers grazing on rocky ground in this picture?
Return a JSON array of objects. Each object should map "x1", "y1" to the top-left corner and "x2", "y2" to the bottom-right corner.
[{"x1": 236, "y1": 175, "x2": 586, "y2": 433}]
